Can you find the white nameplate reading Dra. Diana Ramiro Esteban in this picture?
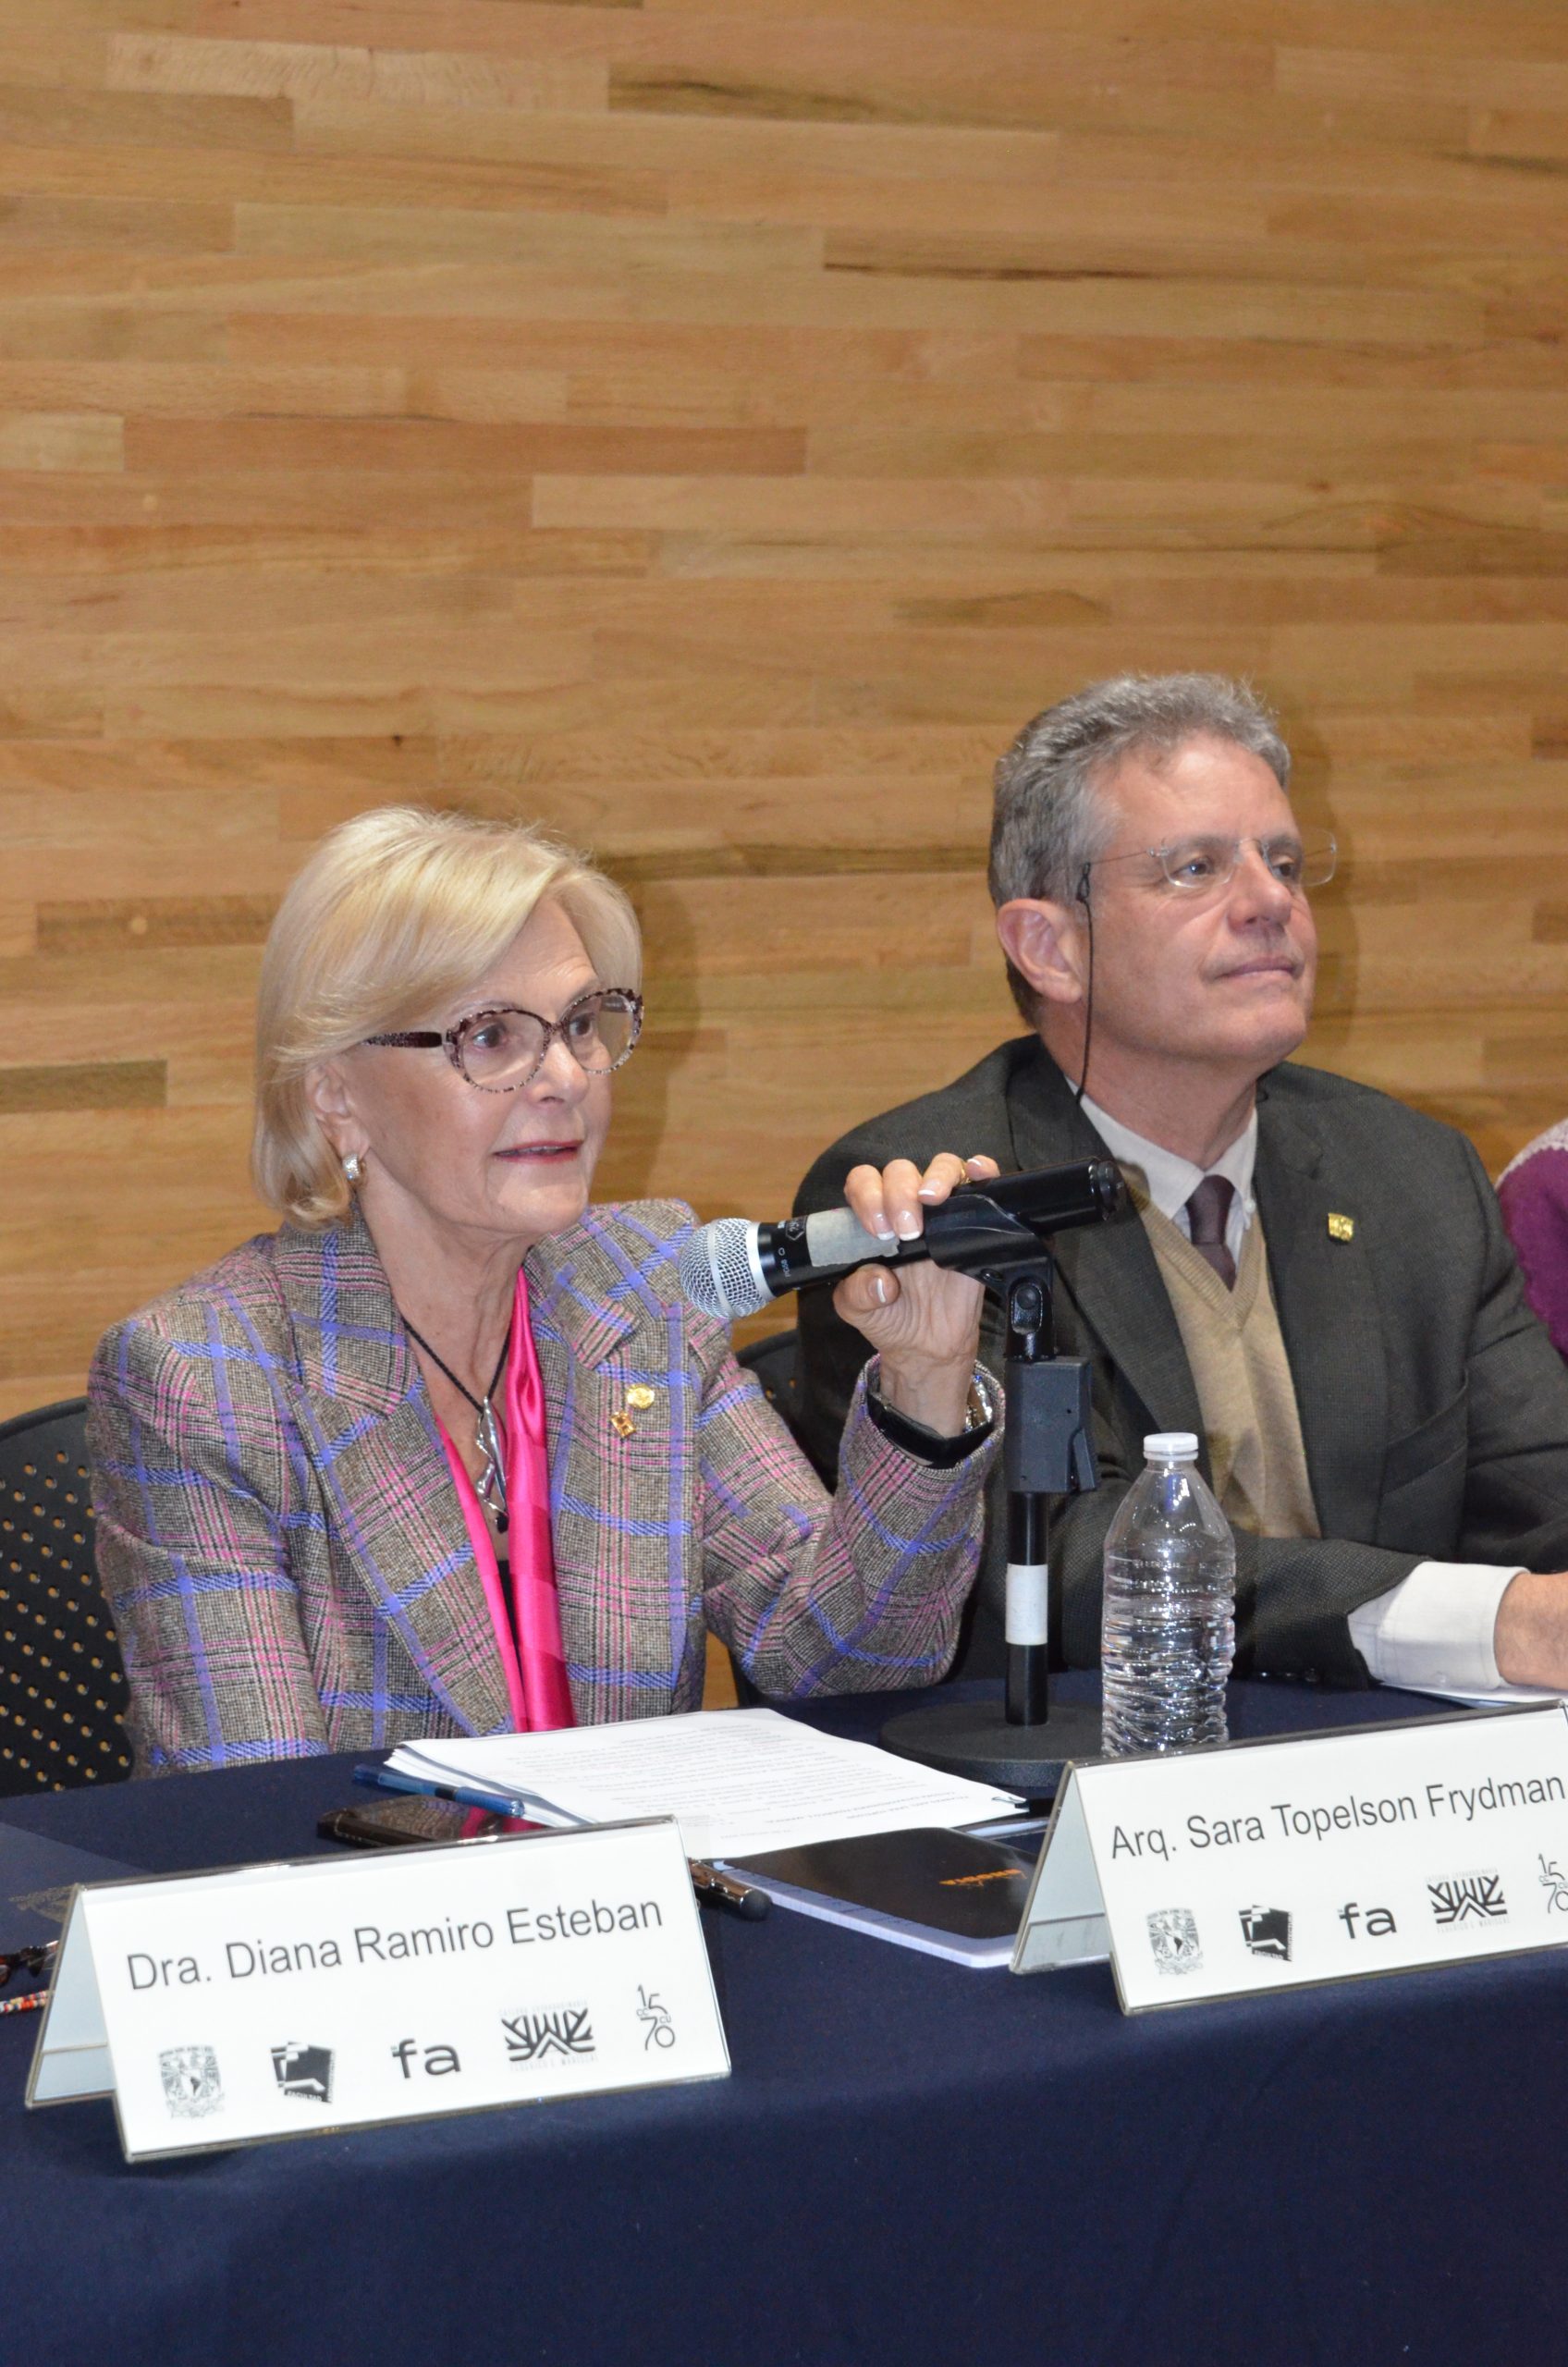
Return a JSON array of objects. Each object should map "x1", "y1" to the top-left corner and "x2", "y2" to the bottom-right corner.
[{"x1": 29, "y1": 1818, "x2": 729, "y2": 2161}]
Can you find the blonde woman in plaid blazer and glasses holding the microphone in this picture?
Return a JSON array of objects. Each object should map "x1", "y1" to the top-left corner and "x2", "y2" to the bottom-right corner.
[{"x1": 88, "y1": 807, "x2": 995, "y2": 1772}]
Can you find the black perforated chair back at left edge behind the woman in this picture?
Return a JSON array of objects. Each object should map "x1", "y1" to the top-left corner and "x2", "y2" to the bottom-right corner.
[{"x1": 0, "y1": 1396, "x2": 130, "y2": 1799}]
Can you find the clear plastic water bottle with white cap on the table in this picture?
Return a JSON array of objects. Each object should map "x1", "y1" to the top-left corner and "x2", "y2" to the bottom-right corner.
[{"x1": 1099, "y1": 1429, "x2": 1236, "y2": 1759}]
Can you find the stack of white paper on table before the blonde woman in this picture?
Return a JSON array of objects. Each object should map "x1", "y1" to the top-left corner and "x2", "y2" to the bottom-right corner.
[{"x1": 388, "y1": 1709, "x2": 1019, "y2": 1858}]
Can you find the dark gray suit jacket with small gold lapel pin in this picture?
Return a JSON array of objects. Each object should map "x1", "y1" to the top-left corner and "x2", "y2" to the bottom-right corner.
[{"x1": 796, "y1": 1036, "x2": 1568, "y2": 1686}]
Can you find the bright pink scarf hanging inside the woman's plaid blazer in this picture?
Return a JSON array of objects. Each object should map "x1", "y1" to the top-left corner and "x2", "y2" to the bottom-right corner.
[{"x1": 435, "y1": 1267, "x2": 576, "y2": 1735}]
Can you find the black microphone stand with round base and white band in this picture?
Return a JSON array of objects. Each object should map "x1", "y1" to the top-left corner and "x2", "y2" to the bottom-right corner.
[{"x1": 881, "y1": 1245, "x2": 1099, "y2": 1801}]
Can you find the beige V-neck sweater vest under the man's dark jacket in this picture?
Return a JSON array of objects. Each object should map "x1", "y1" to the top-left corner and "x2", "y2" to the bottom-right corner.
[{"x1": 1137, "y1": 1193, "x2": 1322, "y2": 1536}]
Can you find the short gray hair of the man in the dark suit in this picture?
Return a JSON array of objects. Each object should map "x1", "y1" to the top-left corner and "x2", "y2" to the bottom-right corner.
[{"x1": 990, "y1": 675, "x2": 1291, "y2": 1027}]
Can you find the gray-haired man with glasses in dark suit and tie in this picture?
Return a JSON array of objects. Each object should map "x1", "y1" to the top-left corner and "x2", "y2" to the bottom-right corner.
[{"x1": 796, "y1": 675, "x2": 1568, "y2": 1695}]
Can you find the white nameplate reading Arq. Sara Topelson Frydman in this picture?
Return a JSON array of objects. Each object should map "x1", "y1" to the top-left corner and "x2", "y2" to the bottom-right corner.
[{"x1": 1011, "y1": 1702, "x2": 1568, "y2": 2015}]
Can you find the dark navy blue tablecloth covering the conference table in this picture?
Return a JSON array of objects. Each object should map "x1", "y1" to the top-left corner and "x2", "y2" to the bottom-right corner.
[{"x1": 0, "y1": 1686, "x2": 1568, "y2": 2367}]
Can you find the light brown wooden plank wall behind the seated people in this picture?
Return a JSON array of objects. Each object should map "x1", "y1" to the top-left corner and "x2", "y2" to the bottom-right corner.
[{"x1": 0, "y1": 0, "x2": 1568, "y2": 1413}]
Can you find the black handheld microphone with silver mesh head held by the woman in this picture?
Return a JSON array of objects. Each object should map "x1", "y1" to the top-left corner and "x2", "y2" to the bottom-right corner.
[{"x1": 680, "y1": 1159, "x2": 1122, "y2": 1323}]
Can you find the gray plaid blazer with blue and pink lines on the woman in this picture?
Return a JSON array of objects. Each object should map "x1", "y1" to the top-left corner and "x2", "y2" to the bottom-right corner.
[{"x1": 88, "y1": 1200, "x2": 995, "y2": 1772}]
